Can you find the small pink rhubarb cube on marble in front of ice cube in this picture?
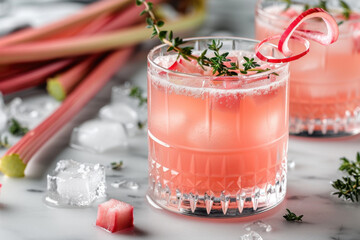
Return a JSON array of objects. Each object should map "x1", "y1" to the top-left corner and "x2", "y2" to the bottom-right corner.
[{"x1": 96, "y1": 199, "x2": 134, "y2": 233}]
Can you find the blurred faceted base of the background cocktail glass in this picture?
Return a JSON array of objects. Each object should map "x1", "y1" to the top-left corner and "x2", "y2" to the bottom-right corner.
[{"x1": 289, "y1": 114, "x2": 360, "y2": 137}]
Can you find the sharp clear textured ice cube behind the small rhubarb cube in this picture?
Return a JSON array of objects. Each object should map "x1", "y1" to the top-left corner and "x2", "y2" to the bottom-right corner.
[{"x1": 45, "y1": 160, "x2": 106, "y2": 207}]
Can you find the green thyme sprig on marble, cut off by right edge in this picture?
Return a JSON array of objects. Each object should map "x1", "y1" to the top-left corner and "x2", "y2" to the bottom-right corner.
[{"x1": 331, "y1": 153, "x2": 360, "y2": 202}]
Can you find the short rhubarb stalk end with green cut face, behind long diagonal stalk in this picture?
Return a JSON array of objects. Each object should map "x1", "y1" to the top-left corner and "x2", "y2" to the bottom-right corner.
[{"x1": 47, "y1": 56, "x2": 99, "y2": 101}]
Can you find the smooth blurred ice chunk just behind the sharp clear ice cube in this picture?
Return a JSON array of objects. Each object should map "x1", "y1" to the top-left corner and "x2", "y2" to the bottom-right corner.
[{"x1": 70, "y1": 119, "x2": 128, "y2": 153}]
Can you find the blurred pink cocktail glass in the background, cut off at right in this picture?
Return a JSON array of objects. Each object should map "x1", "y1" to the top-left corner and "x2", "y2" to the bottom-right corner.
[{"x1": 255, "y1": 0, "x2": 360, "y2": 136}]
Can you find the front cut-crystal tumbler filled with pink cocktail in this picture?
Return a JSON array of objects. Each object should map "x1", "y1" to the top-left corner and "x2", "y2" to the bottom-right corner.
[{"x1": 148, "y1": 37, "x2": 289, "y2": 217}]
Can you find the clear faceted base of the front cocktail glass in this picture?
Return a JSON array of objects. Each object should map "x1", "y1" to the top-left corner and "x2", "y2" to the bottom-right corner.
[{"x1": 147, "y1": 176, "x2": 286, "y2": 218}]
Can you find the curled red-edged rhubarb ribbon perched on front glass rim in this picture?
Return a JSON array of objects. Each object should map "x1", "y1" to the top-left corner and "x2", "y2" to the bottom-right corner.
[{"x1": 255, "y1": 8, "x2": 339, "y2": 63}]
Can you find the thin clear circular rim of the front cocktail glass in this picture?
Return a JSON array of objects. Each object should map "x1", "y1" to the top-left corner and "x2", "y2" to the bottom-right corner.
[{"x1": 147, "y1": 36, "x2": 289, "y2": 81}]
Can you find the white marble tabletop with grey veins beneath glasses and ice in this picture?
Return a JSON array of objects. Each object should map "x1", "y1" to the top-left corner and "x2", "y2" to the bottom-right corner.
[{"x1": 0, "y1": 0, "x2": 360, "y2": 240}]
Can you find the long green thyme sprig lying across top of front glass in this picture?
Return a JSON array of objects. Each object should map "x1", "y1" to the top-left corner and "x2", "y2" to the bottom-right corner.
[{"x1": 136, "y1": 0, "x2": 271, "y2": 76}]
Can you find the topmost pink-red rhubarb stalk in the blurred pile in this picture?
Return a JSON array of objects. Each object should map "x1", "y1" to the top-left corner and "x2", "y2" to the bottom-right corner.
[{"x1": 0, "y1": 0, "x2": 133, "y2": 47}]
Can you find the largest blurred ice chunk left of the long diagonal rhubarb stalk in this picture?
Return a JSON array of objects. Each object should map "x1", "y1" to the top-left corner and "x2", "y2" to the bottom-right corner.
[{"x1": 9, "y1": 98, "x2": 60, "y2": 128}]
